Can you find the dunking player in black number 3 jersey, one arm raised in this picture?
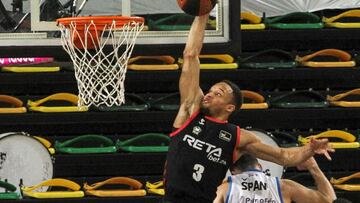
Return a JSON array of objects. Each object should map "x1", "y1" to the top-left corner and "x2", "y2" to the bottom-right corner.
[{"x1": 163, "y1": 15, "x2": 333, "y2": 203}]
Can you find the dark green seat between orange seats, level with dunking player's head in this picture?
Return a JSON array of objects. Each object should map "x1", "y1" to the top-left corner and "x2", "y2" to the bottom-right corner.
[{"x1": 270, "y1": 90, "x2": 329, "y2": 108}]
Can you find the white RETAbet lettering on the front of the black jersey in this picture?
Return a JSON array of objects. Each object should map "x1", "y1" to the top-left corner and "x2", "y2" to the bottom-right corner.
[{"x1": 183, "y1": 134, "x2": 226, "y2": 165}]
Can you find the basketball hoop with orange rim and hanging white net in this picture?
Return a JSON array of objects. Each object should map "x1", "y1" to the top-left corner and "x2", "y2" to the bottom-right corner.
[{"x1": 57, "y1": 16, "x2": 144, "y2": 107}]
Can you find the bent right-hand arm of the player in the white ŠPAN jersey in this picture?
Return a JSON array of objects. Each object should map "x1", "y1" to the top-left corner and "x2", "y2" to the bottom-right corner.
[{"x1": 281, "y1": 157, "x2": 336, "y2": 203}]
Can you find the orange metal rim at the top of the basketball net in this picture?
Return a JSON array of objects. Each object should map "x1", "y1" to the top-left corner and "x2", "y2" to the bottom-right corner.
[{"x1": 56, "y1": 16, "x2": 144, "y2": 30}]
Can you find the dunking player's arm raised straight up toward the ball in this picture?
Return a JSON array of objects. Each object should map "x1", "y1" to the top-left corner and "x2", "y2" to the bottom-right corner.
[{"x1": 173, "y1": 14, "x2": 209, "y2": 128}]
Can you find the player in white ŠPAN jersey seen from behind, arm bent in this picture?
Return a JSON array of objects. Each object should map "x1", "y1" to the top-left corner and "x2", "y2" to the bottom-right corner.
[{"x1": 214, "y1": 154, "x2": 336, "y2": 203}]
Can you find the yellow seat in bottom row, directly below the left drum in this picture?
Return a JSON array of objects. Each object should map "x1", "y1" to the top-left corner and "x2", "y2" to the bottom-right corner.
[{"x1": 21, "y1": 178, "x2": 84, "y2": 199}]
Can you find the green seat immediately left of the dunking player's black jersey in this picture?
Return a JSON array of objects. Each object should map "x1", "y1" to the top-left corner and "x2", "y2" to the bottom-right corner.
[{"x1": 116, "y1": 133, "x2": 170, "y2": 152}]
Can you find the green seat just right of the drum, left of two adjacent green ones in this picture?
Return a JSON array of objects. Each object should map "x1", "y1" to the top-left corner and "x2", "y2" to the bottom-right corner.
[{"x1": 55, "y1": 135, "x2": 117, "y2": 154}]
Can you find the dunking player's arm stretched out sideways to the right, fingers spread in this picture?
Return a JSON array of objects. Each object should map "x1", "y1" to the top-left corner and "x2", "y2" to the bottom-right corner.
[{"x1": 238, "y1": 129, "x2": 334, "y2": 166}]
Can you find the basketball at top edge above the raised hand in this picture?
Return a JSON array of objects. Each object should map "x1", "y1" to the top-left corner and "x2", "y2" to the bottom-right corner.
[{"x1": 177, "y1": 0, "x2": 217, "y2": 16}]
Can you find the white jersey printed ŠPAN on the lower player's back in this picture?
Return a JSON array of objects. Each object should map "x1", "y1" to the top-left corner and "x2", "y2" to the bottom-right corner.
[{"x1": 225, "y1": 170, "x2": 283, "y2": 203}]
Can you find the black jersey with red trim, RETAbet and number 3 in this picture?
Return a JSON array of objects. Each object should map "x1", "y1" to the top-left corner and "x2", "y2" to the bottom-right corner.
[{"x1": 164, "y1": 112, "x2": 240, "y2": 203}]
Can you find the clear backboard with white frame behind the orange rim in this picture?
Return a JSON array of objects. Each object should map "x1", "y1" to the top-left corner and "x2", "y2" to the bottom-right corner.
[{"x1": 0, "y1": 0, "x2": 233, "y2": 47}]
